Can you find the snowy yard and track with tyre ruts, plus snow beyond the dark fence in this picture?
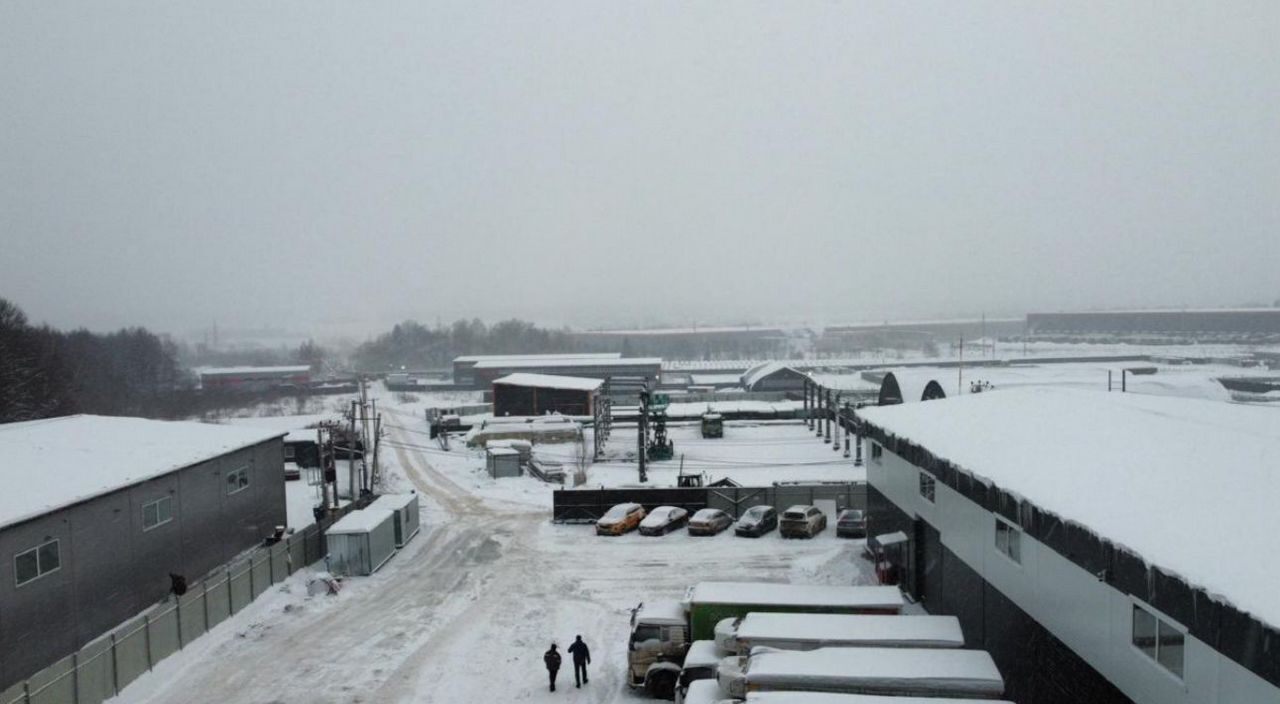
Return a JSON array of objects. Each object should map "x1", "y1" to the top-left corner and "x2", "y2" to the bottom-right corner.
[{"x1": 118, "y1": 399, "x2": 870, "y2": 704}]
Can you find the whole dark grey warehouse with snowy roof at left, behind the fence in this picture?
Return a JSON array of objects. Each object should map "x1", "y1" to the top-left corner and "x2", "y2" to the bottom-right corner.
[{"x1": 0, "y1": 416, "x2": 285, "y2": 690}]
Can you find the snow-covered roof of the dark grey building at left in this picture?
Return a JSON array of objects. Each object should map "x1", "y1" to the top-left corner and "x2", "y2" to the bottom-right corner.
[{"x1": 0, "y1": 415, "x2": 284, "y2": 527}]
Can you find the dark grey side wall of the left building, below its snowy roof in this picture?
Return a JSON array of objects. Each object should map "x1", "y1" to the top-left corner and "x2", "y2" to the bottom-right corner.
[{"x1": 0, "y1": 439, "x2": 285, "y2": 690}]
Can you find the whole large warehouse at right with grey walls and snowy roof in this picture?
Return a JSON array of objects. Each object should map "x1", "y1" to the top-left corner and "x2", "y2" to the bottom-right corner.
[{"x1": 859, "y1": 388, "x2": 1280, "y2": 704}]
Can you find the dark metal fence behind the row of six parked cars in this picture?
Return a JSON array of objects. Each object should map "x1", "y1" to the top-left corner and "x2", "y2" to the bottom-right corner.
[{"x1": 552, "y1": 481, "x2": 867, "y2": 524}]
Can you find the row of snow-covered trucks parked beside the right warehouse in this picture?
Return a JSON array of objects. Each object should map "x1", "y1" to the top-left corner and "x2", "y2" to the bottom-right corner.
[{"x1": 627, "y1": 582, "x2": 1007, "y2": 704}]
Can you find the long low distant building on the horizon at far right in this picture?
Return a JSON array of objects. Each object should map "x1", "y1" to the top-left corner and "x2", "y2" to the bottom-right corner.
[{"x1": 1027, "y1": 307, "x2": 1280, "y2": 342}]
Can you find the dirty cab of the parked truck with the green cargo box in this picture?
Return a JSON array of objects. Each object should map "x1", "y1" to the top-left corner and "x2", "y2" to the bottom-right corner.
[{"x1": 627, "y1": 602, "x2": 690, "y2": 699}]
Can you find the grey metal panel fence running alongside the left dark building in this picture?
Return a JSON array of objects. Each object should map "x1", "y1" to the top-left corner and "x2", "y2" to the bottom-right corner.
[{"x1": 0, "y1": 504, "x2": 357, "y2": 704}]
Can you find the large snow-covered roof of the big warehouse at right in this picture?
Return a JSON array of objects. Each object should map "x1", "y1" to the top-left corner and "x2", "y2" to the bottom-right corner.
[{"x1": 859, "y1": 388, "x2": 1280, "y2": 626}]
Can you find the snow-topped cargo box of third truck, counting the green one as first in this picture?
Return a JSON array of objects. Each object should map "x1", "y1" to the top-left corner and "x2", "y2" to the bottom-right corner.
[{"x1": 746, "y1": 648, "x2": 1005, "y2": 696}]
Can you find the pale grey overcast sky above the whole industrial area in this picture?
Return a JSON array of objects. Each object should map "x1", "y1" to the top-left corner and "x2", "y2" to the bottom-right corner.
[{"x1": 0, "y1": 0, "x2": 1280, "y2": 333}]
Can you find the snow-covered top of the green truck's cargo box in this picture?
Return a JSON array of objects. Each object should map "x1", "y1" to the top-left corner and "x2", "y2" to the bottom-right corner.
[{"x1": 686, "y1": 582, "x2": 904, "y2": 609}]
